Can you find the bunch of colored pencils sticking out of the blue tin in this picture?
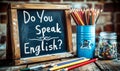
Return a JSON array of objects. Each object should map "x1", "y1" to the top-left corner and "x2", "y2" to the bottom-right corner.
[{"x1": 71, "y1": 8, "x2": 102, "y2": 26}]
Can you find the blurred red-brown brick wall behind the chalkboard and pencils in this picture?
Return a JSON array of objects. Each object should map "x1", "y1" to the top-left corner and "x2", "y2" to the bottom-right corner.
[{"x1": 0, "y1": 0, "x2": 120, "y2": 57}]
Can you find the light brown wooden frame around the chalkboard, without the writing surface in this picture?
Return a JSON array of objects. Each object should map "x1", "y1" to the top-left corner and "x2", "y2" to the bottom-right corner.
[{"x1": 10, "y1": 4, "x2": 73, "y2": 65}]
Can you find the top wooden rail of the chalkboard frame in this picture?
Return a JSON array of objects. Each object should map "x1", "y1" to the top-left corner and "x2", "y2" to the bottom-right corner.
[{"x1": 11, "y1": 3, "x2": 70, "y2": 9}]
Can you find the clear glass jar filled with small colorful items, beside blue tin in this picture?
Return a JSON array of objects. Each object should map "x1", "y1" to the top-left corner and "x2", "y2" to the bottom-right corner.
[{"x1": 97, "y1": 32, "x2": 117, "y2": 59}]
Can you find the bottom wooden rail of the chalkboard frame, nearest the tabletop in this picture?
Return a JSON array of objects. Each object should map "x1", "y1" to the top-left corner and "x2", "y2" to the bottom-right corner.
[{"x1": 15, "y1": 53, "x2": 73, "y2": 65}]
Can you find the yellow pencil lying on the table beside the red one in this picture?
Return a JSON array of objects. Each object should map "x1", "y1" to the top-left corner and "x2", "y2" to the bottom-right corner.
[{"x1": 49, "y1": 59, "x2": 89, "y2": 71}]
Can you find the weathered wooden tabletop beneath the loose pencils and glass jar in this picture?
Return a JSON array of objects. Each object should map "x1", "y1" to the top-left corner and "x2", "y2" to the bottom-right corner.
[{"x1": 0, "y1": 59, "x2": 120, "y2": 71}]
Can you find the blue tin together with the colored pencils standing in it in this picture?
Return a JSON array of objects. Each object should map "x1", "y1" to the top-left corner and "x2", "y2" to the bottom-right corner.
[{"x1": 70, "y1": 8, "x2": 102, "y2": 58}]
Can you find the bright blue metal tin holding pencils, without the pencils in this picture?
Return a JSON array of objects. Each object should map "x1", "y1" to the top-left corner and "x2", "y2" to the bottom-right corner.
[{"x1": 76, "y1": 25, "x2": 95, "y2": 58}]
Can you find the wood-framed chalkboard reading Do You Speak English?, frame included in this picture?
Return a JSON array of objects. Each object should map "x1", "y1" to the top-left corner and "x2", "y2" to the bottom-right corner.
[{"x1": 8, "y1": 3, "x2": 74, "y2": 65}]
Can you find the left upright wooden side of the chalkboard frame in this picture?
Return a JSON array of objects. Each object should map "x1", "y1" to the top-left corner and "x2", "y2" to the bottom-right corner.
[{"x1": 11, "y1": 9, "x2": 20, "y2": 59}]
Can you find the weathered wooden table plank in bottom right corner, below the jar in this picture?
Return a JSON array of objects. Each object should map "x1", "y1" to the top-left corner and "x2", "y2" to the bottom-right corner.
[{"x1": 96, "y1": 60, "x2": 120, "y2": 71}]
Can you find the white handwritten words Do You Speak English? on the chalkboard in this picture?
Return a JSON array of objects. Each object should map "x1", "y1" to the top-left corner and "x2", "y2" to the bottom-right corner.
[{"x1": 23, "y1": 10, "x2": 63, "y2": 56}]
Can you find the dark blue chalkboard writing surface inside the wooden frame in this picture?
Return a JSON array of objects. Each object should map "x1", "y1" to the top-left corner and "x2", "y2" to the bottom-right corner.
[{"x1": 17, "y1": 9, "x2": 67, "y2": 58}]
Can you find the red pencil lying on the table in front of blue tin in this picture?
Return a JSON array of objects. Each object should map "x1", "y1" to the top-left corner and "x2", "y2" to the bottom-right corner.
[{"x1": 63, "y1": 58, "x2": 98, "y2": 71}]
